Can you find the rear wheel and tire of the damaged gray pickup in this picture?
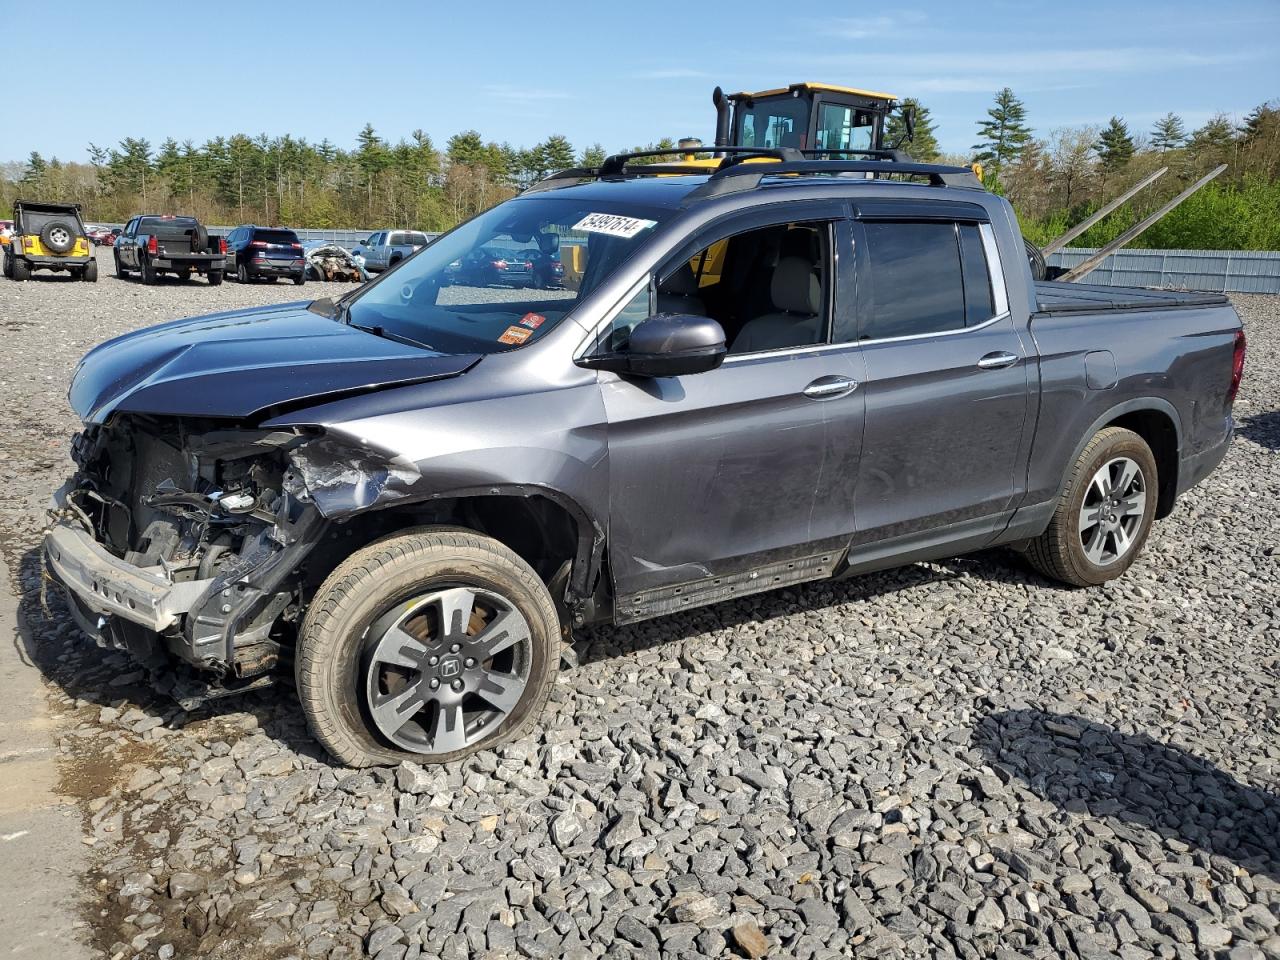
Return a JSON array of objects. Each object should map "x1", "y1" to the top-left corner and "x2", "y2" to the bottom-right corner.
[{"x1": 1027, "y1": 426, "x2": 1160, "y2": 586}]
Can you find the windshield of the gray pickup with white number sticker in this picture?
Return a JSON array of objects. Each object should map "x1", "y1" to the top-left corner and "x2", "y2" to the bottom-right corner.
[{"x1": 347, "y1": 195, "x2": 672, "y2": 353}]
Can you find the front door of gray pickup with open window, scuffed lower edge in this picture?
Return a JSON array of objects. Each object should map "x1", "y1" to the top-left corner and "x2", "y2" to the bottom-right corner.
[{"x1": 600, "y1": 211, "x2": 864, "y2": 622}]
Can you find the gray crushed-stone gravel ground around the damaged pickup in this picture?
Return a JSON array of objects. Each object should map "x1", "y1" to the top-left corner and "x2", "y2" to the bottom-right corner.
[{"x1": 0, "y1": 249, "x2": 1280, "y2": 960}]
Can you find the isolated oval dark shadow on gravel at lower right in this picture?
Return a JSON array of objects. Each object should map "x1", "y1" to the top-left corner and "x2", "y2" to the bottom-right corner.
[{"x1": 974, "y1": 709, "x2": 1280, "y2": 879}]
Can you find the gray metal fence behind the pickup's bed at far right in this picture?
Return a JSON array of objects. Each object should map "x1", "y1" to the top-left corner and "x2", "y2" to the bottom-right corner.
[{"x1": 1047, "y1": 247, "x2": 1280, "y2": 293}]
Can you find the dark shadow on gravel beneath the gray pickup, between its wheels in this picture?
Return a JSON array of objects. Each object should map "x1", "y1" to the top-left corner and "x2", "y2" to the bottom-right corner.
[{"x1": 576, "y1": 549, "x2": 1073, "y2": 663}]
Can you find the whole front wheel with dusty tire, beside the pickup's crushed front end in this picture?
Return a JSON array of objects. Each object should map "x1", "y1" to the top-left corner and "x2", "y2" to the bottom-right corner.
[{"x1": 302, "y1": 527, "x2": 561, "y2": 767}]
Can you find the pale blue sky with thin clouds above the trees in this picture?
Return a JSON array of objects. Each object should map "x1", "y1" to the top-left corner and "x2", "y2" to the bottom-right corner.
[{"x1": 0, "y1": 0, "x2": 1280, "y2": 160}]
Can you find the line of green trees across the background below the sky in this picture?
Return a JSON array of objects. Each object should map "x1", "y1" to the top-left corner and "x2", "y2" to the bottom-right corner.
[{"x1": 0, "y1": 94, "x2": 1280, "y2": 250}]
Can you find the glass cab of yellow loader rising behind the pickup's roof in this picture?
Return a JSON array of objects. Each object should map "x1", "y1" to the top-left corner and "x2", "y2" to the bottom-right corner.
[{"x1": 717, "y1": 83, "x2": 897, "y2": 151}]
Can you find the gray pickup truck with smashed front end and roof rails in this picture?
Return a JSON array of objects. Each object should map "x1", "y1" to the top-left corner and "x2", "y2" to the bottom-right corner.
[{"x1": 45, "y1": 151, "x2": 1244, "y2": 765}]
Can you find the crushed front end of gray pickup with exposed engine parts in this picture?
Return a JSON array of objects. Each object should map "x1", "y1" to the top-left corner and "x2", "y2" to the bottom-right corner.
[{"x1": 45, "y1": 415, "x2": 328, "y2": 691}]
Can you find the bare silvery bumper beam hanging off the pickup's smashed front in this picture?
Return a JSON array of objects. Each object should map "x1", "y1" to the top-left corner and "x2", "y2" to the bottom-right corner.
[{"x1": 45, "y1": 521, "x2": 214, "y2": 639}]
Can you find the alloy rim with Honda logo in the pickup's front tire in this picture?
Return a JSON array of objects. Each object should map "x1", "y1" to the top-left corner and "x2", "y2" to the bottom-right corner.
[{"x1": 362, "y1": 586, "x2": 532, "y2": 756}]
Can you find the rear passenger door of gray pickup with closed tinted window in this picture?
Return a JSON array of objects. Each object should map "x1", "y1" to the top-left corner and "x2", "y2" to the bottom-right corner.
[{"x1": 851, "y1": 201, "x2": 1030, "y2": 564}]
